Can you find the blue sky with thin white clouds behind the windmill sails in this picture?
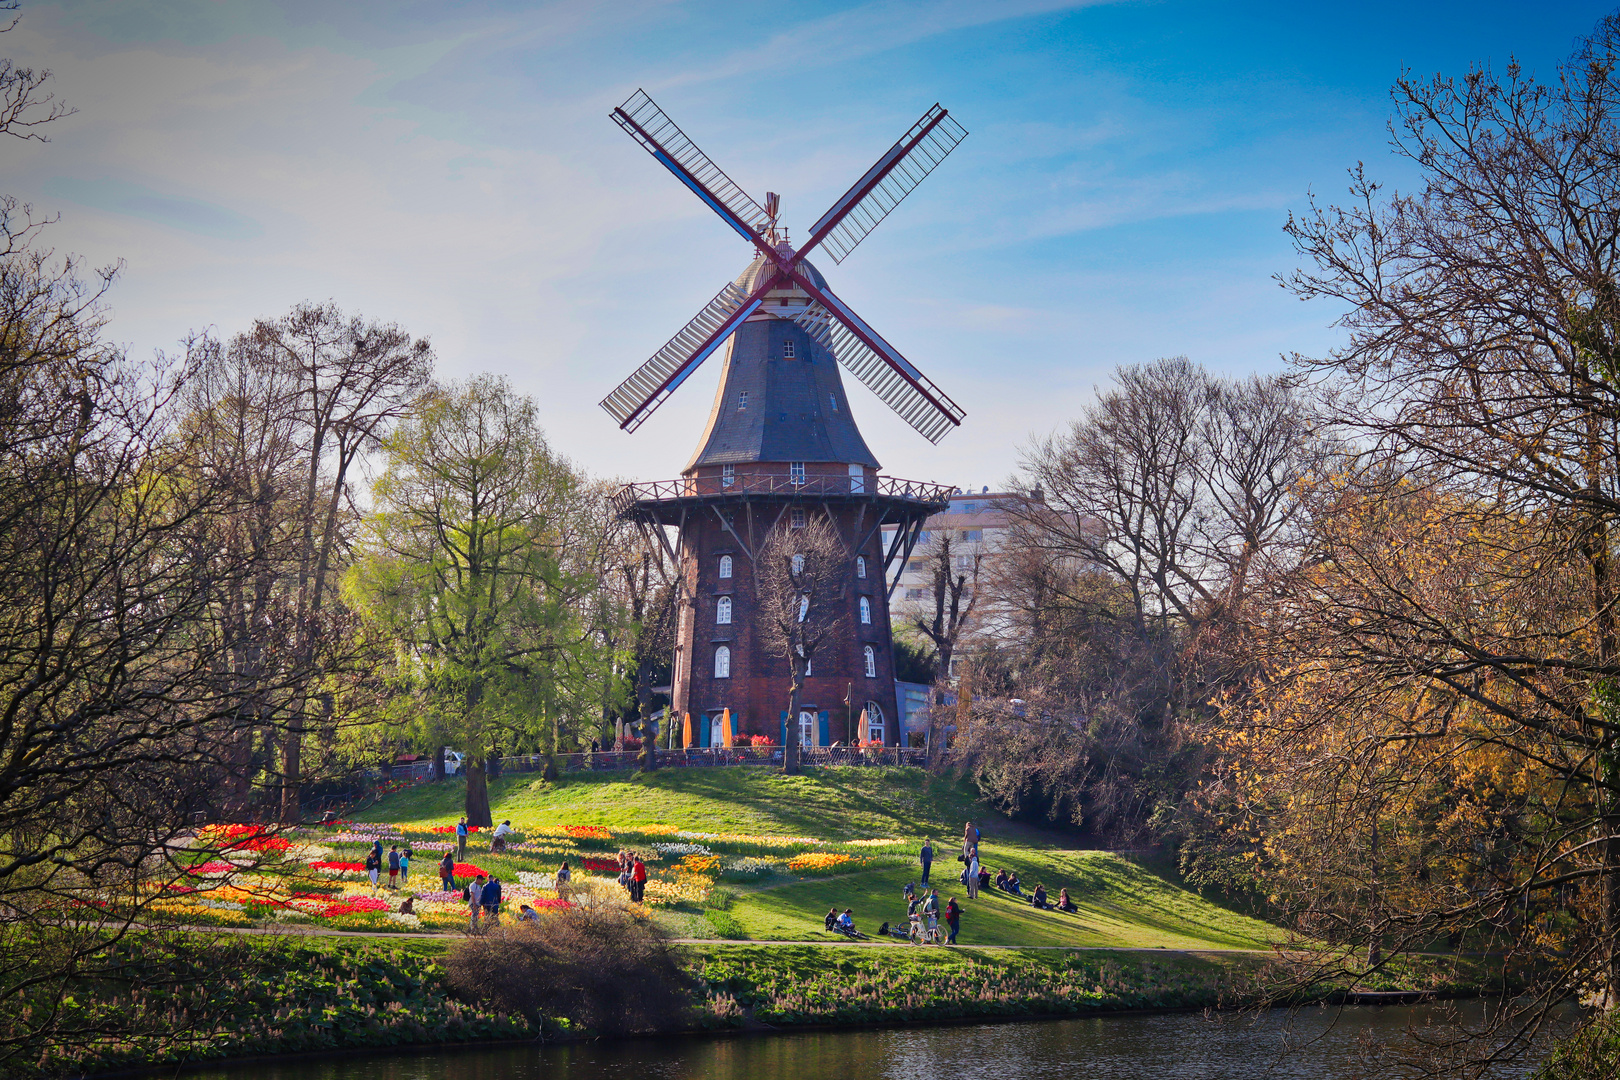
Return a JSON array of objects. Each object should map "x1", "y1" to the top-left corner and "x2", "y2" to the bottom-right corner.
[{"x1": 0, "y1": 0, "x2": 1614, "y2": 487}]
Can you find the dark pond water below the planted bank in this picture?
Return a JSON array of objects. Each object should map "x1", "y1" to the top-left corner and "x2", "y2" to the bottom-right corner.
[{"x1": 188, "y1": 1006, "x2": 1548, "y2": 1080}]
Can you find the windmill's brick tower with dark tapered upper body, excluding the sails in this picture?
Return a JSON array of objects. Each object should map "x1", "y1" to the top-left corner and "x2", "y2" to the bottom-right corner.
[{"x1": 619, "y1": 257, "x2": 949, "y2": 746}]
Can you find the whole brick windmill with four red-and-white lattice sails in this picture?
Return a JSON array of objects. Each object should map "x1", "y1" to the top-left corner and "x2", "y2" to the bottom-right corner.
[{"x1": 601, "y1": 91, "x2": 967, "y2": 759}]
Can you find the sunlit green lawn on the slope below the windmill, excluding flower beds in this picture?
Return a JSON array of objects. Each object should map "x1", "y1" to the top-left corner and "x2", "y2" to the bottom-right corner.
[{"x1": 356, "y1": 767, "x2": 1275, "y2": 950}]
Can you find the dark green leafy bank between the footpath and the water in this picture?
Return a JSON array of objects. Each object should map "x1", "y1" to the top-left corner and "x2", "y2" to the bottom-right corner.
[{"x1": 38, "y1": 938, "x2": 1503, "y2": 1077}]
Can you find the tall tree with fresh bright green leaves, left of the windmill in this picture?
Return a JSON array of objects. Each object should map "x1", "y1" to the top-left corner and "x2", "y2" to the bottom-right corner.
[{"x1": 347, "y1": 376, "x2": 595, "y2": 826}]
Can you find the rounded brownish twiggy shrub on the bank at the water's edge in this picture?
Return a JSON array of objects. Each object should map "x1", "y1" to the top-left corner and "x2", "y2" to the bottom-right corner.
[{"x1": 446, "y1": 907, "x2": 689, "y2": 1035}]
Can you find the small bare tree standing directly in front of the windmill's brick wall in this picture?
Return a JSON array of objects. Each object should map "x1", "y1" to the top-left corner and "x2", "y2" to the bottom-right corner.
[{"x1": 753, "y1": 515, "x2": 851, "y2": 772}]
